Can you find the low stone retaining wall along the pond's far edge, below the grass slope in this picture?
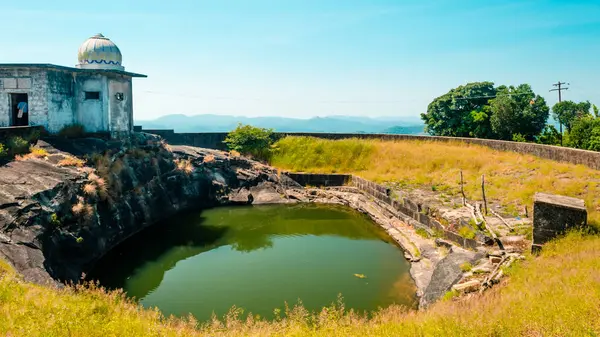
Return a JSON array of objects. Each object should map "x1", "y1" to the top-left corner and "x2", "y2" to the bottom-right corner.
[{"x1": 285, "y1": 172, "x2": 482, "y2": 249}]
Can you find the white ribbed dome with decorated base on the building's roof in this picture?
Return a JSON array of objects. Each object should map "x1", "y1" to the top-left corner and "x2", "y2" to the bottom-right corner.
[{"x1": 77, "y1": 34, "x2": 125, "y2": 70}]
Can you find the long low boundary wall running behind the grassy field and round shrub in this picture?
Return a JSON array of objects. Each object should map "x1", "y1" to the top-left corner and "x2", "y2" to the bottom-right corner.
[{"x1": 136, "y1": 126, "x2": 600, "y2": 170}]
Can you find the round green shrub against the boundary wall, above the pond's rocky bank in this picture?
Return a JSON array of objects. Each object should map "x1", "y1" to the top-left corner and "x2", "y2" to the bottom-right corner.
[{"x1": 224, "y1": 124, "x2": 273, "y2": 160}]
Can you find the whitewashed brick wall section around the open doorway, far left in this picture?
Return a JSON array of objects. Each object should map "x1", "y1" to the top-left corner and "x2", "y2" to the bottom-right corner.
[{"x1": 0, "y1": 68, "x2": 48, "y2": 128}]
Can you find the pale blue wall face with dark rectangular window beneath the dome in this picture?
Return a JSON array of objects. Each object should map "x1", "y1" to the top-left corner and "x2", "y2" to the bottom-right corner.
[{"x1": 75, "y1": 74, "x2": 109, "y2": 132}]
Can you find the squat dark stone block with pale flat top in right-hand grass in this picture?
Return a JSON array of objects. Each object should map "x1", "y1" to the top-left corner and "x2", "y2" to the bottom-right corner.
[{"x1": 533, "y1": 193, "x2": 587, "y2": 246}]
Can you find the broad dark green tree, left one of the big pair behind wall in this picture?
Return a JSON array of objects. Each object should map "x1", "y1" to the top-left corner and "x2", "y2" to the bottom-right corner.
[{"x1": 421, "y1": 82, "x2": 496, "y2": 138}]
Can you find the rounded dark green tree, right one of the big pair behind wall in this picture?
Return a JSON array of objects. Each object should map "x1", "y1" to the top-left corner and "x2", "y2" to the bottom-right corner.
[{"x1": 490, "y1": 84, "x2": 549, "y2": 141}]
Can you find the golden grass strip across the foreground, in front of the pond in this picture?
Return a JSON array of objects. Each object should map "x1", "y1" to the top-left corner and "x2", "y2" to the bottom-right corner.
[{"x1": 0, "y1": 233, "x2": 600, "y2": 336}]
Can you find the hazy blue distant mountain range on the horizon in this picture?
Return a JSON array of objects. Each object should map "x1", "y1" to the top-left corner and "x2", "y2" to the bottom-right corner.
[{"x1": 135, "y1": 114, "x2": 423, "y2": 134}]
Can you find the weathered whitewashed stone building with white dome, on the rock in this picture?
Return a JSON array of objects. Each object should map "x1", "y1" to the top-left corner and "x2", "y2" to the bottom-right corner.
[{"x1": 0, "y1": 34, "x2": 146, "y2": 136}]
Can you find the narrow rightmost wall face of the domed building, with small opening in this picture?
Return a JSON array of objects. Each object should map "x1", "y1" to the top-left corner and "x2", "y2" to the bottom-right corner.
[{"x1": 108, "y1": 76, "x2": 133, "y2": 132}]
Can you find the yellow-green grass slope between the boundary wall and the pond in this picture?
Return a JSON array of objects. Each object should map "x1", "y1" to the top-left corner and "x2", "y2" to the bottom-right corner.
[{"x1": 270, "y1": 137, "x2": 600, "y2": 226}]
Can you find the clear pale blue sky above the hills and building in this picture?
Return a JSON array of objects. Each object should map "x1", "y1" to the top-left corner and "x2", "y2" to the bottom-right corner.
[{"x1": 0, "y1": 0, "x2": 600, "y2": 119}]
